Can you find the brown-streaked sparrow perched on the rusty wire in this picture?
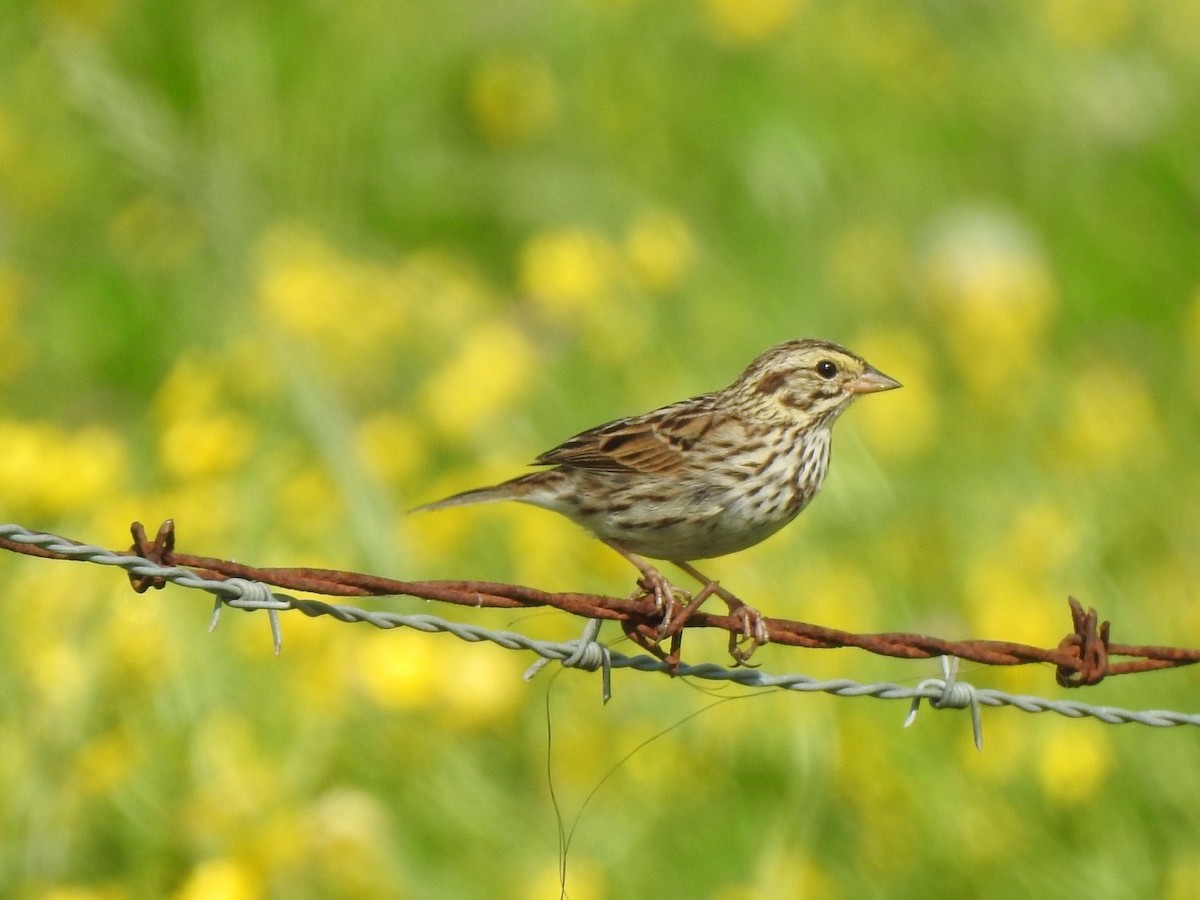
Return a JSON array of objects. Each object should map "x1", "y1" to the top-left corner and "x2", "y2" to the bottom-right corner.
[{"x1": 418, "y1": 340, "x2": 900, "y2": 659}]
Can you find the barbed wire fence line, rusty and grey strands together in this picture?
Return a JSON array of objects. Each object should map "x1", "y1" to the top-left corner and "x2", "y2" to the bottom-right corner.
[{"x1": 0, "y1": 520, "x2": 1200, "y2": 746}]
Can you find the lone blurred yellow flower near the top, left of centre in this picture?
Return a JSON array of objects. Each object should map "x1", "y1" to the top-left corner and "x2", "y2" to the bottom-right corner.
[{"x1": 469, "y1": 53, "x2": 558, "y2": 145}]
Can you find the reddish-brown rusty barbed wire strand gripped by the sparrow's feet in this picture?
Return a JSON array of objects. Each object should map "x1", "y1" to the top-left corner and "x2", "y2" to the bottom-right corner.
[{"x1": 0, "y1": 520, "x2": 1200, "y2": 688}]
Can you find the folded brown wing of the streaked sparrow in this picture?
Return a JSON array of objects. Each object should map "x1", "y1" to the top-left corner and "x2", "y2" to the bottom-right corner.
[{"x1": 534, "y1": 395, "x2": 721, "y2": 475}]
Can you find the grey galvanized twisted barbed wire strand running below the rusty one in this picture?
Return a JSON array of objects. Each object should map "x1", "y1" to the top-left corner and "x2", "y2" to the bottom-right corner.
[{"x1": 0, "y1": 524, "x2": 1200, "y2": 744}]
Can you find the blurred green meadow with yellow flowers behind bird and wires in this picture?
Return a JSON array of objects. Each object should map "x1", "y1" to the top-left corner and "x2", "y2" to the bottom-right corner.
[{"x1": 0, "y1": 0, "x2": 1200, "y2": 900}]
